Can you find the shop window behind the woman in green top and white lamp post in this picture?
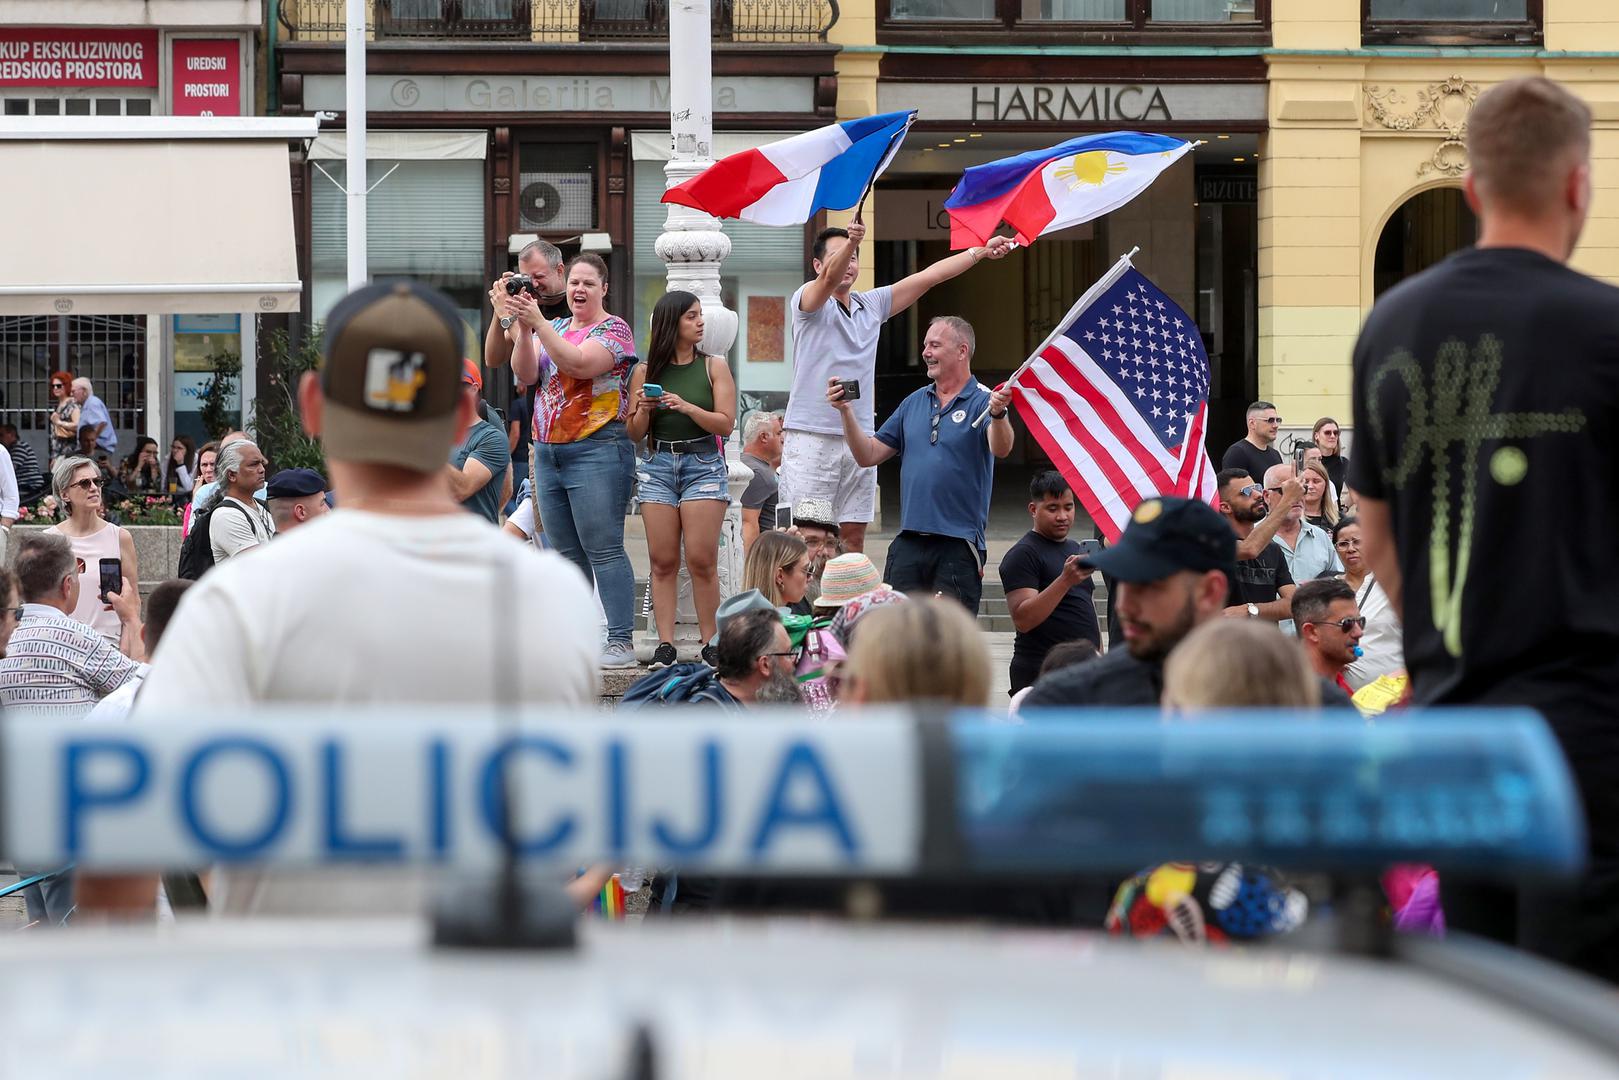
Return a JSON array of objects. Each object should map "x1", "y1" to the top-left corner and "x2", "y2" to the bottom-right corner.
[{"x1": 631, "y1": 158, "x2": 806, "y2": 399}]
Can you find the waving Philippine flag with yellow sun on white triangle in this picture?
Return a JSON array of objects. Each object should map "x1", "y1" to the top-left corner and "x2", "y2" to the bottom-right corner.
[{"x1": 944, "y1": 131, "x2": 1192, "y2": 248}]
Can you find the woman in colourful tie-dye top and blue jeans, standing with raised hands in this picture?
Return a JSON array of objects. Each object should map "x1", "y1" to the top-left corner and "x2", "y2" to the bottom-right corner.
[{"x1": 510, "y1": 254, "x2": 635, "y2": 667}]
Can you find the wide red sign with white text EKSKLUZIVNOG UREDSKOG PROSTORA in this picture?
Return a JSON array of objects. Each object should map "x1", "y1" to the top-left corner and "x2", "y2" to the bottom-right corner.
[{"x1": 0, "y1": 28, "x2": 157, "y2": 86}]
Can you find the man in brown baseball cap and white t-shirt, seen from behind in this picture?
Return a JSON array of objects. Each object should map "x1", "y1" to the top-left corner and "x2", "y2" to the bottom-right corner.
[{"x1": 134, "y1": 282, "x2": 606, "y2": 913}]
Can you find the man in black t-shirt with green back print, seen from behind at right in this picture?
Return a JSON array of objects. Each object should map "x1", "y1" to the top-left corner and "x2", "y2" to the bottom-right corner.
[{"x1": 1349, "y1": 78, "x2": 1619, "y2": 980}]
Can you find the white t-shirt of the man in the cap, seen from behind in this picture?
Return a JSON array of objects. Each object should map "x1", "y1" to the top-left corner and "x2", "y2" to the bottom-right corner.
[{"x1": 131, "y1": 510, "x2": 601, "y2": 915}]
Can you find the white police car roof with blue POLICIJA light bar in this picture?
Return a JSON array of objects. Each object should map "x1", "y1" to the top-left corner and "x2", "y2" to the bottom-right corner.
[{"x1": 0, "y1": 712, "x2": 1619, "y2": 1078}]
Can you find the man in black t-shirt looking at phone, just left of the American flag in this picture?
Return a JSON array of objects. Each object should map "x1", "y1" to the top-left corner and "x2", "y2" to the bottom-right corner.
[{"x1": 1001, "y1": 470, "x2": 1103, "y2": 693}]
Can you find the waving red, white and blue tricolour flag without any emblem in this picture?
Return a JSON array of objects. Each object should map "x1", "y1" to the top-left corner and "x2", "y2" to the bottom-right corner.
[{"x1": 664, "y1": 112, "x2": 916, "y2": 225}]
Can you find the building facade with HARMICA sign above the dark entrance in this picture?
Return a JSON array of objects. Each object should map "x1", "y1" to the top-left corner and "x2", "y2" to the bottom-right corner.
[{"x1": 834, "y1": 0, "x2": 1271, "y2": 463}]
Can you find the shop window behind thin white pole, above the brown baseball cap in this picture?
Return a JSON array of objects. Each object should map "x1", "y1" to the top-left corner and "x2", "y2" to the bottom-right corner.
[{"x1": 309, "y1": 160, "x2": 489, "y2": 338}]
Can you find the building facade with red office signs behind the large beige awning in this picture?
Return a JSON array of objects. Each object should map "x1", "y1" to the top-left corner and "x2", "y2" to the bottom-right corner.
[{"x1": 0, "y1": 0, "x2": 264, "y2": 453}]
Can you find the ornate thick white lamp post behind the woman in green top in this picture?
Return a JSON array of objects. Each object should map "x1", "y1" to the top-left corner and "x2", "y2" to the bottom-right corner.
[{"x1": 646, "y1": 0, "x2": 750, "y2": 654}]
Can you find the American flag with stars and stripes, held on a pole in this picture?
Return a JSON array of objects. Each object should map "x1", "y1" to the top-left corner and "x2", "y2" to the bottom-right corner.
[{"x1": 1012, "y1": 259, "x2": 1216, "y2": 541}]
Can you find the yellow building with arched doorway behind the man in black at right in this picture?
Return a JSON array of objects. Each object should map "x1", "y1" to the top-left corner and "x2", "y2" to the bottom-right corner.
[{"x1": 1258, "y1": 0, "x2": 1619, "y2": 440}]
